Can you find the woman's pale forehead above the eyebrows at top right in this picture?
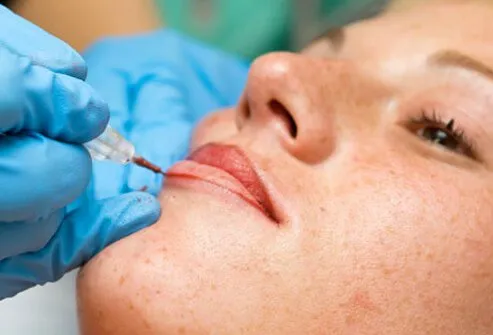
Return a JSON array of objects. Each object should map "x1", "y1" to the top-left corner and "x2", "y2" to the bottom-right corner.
[{"x1": 303, "y1": 0, "x2": 493, "y2": 88}]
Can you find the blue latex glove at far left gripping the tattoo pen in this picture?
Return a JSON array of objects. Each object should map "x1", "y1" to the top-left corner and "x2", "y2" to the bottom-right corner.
[{"x1": 0, "y1": 6, "x2": 159, "y2": 299}]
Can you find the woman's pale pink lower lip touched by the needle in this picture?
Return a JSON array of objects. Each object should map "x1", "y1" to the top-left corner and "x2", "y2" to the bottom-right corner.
[{"x1": 165, "y1": 161, "x2": 271, "y2": 218}]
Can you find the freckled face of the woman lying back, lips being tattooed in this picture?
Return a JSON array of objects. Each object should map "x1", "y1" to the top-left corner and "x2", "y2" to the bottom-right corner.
[{"x1": 79, "y1": 3, "x2": 493, "y2": 335}]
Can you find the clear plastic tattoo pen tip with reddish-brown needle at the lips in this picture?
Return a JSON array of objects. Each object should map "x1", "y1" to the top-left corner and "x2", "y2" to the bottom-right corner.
[{"x1": 84, "y1": 126, "x2": 165, "y2": 175}]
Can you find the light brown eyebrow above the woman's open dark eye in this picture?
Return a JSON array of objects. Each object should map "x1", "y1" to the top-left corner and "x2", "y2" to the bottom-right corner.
[{"x1": 428, "y1": 50, "x2": 493, "y2": 80}]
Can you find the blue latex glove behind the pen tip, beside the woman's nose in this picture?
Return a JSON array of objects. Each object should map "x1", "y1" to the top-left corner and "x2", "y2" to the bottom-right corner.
[{"x1": 84, "y1": 29, "x2": 248, "y2": 197}]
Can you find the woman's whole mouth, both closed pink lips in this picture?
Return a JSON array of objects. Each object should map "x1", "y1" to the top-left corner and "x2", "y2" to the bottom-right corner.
[{"x1": 166, "y1": 144, "x2": 277, "y2": 222}]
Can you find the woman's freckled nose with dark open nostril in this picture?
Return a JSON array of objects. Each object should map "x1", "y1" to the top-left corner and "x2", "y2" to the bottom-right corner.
[{"x1": 237, "y1": 53, "x2": 335, "y2": 163}]
